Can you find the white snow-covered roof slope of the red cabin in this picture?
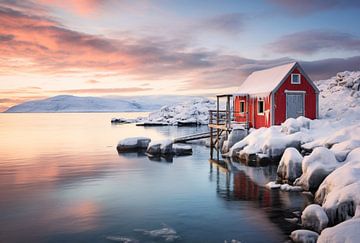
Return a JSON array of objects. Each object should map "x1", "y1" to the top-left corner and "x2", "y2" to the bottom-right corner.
[{"x1": 239, "y1": 62, "x2": 296, "y2": 95}]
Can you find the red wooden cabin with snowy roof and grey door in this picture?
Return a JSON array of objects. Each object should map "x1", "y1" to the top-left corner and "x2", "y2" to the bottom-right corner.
[{"x1": 233, "y1": 62, "x2": 319, "y2": 128}]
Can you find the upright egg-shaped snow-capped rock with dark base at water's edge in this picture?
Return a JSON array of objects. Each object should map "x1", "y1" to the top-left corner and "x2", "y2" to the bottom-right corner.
[{"x1": 277, "y1": 148, "x2": 303, "y2": 183}]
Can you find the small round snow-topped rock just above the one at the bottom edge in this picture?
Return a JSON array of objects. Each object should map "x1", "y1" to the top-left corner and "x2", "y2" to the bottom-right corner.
[{"x1": 301, "y1": 204, "x2": 329, "y2": 233}]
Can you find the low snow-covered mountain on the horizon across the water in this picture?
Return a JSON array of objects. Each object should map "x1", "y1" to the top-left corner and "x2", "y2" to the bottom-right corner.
[{"x1": 5, "y1": 95, "x2": 200, "y2": 113}]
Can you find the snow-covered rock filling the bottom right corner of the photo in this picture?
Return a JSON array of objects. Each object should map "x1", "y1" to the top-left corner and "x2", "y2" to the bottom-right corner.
[{"x1": 317, "y1": 218, "x2": 360, "y2": 243}]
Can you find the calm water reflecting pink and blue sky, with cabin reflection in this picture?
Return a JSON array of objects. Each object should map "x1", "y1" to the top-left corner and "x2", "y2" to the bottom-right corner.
[{"x1": 0, "y1": 113, "x2": 307, "y2": 242}]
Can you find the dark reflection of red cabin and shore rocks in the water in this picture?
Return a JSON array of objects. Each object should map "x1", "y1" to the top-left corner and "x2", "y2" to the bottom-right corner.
[{"x1": 210, "y1": 160, "x2": 310, "y2": 235}]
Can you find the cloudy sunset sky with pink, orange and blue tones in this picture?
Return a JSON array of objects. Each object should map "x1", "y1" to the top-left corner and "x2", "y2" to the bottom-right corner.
[{"x1": 0, "y1": 0, "x2": 360, "y2": 111}]
